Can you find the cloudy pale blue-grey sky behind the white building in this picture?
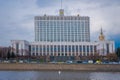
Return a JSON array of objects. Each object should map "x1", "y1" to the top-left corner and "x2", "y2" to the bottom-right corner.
[{"x1": 0, "y1": 0, "x2": 120, "y2": 47}]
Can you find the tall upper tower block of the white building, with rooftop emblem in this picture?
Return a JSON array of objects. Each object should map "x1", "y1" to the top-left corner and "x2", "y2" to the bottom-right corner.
[{"x1": 35, "y1": 11, "x2": 90, "y2": 42}]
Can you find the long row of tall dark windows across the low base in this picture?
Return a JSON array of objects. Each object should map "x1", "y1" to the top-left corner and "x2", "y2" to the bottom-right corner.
[{"x1": 30, "y1": 45, "x2": 97, "y2": 53}]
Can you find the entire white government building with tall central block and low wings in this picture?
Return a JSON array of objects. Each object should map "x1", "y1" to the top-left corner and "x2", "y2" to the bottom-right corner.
[{"x1": 11, "y1": 9, "x2": 115, "y2": 59}]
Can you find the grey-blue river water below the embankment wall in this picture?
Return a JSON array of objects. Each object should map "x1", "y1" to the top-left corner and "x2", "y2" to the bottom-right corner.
[{"x1": 0, "y1": 71, "x2": 120, "y2": 80}]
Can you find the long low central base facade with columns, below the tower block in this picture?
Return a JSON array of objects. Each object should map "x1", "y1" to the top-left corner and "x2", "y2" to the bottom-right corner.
[{"x1": 30, "y1": 42, "x2": 97, "y2": 56}]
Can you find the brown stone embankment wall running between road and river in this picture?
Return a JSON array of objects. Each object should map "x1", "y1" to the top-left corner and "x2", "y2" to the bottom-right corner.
[{"x1": 0, "y1": 63, "x2": 120, "y2": 72}]
